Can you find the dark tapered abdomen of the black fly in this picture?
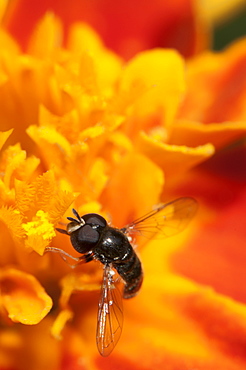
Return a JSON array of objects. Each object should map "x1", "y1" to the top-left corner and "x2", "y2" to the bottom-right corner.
[{"x1": 113, "y1": 251, "x2": 143, "y2": 299}]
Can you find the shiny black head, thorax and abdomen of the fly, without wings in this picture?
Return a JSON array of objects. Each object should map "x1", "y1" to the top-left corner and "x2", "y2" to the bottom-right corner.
[{"x1": 66, "y1": 214, "x2": 143, "y2": 298}]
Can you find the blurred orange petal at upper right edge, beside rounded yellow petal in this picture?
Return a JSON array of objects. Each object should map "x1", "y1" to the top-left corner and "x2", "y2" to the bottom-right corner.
[{"x1": 179, "y1": 39, "x2": 246, "y2": 123}]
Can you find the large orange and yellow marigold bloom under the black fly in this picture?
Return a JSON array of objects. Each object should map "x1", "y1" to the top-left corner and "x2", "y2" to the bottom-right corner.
[{"x1": 0, "y1": 5, "x2": 246, "y2": 370}]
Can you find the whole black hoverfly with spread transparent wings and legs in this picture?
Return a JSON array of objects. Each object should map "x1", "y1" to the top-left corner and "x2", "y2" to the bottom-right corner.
[{"x1": 46, "y1": 197, "x2": 197, "y2": 356}]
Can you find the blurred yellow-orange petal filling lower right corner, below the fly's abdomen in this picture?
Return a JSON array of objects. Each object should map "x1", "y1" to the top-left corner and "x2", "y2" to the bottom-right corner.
[{"x1": 101, "y1": 269, "x2": 246, "y2": 370}]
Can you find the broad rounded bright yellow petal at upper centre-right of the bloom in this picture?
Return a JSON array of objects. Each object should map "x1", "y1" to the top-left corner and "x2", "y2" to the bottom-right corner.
[{"x1": 119, "y1": 49, "x2": 185, "y2": 126}]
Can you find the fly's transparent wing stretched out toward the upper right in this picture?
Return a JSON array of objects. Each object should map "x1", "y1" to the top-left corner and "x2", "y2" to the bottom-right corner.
[{"x1": 121, "y1": 197, "x2": 198, "y2": 238}]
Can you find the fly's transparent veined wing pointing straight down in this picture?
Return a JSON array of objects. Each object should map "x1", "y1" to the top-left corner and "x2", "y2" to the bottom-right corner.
[{"x1": 96, "y1": 265, "x2": 123, "y2": 357}]
